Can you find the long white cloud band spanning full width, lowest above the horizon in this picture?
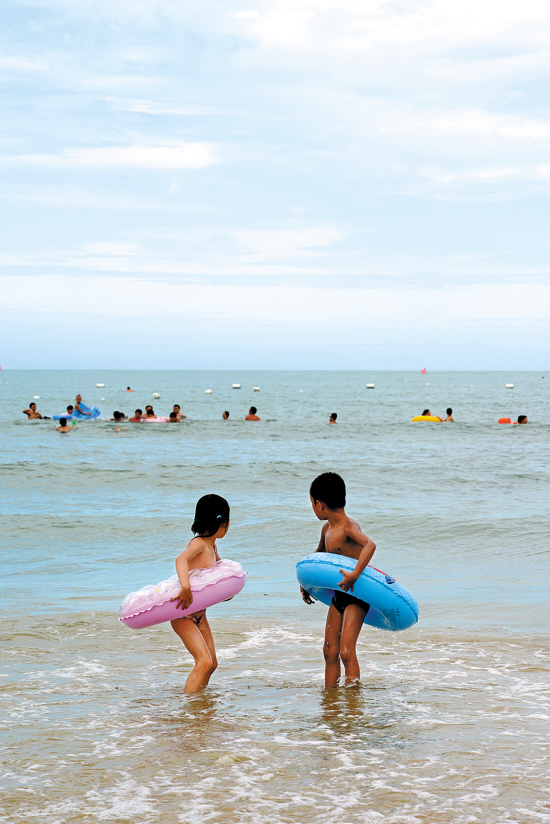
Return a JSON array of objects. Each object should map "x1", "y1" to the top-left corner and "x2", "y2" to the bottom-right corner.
[{"x1": 0, "y1": 275, "x2": 550, "y2": 329}]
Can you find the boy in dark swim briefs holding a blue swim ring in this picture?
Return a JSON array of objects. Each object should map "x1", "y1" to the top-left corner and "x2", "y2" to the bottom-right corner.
[{"x1": 300, "y1": 472, "x2": 376, "y2": 688}]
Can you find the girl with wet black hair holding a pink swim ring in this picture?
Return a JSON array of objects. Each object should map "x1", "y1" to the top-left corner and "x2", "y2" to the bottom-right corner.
[{"x1": 171, "y1": 495, "x2": 229, "y2": 692}]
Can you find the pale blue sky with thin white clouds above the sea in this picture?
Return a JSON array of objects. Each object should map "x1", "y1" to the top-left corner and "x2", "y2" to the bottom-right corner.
[{"x1": 0, "y1": 0, "x2": 550, "y2": 370}]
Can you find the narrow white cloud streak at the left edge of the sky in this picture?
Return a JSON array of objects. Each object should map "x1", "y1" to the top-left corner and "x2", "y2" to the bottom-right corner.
[{"x1": 6, "y1": 143, "x2": 221, "y2": 170}]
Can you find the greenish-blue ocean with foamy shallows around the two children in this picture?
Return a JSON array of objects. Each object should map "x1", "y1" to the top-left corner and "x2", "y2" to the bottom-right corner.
[{"x1": 0, "y1": 370, "x2": 550, "y2": 824}]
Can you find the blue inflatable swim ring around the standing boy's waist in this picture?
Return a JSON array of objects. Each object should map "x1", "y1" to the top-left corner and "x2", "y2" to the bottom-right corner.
[{"x1": 296, "y1": 552, "x2": 418, "y2": 632}]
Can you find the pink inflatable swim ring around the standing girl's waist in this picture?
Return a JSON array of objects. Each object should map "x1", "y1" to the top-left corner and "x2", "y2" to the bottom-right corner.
[{"x1": 119, "y1": 560, "x2": 246, "y2": 629}]
